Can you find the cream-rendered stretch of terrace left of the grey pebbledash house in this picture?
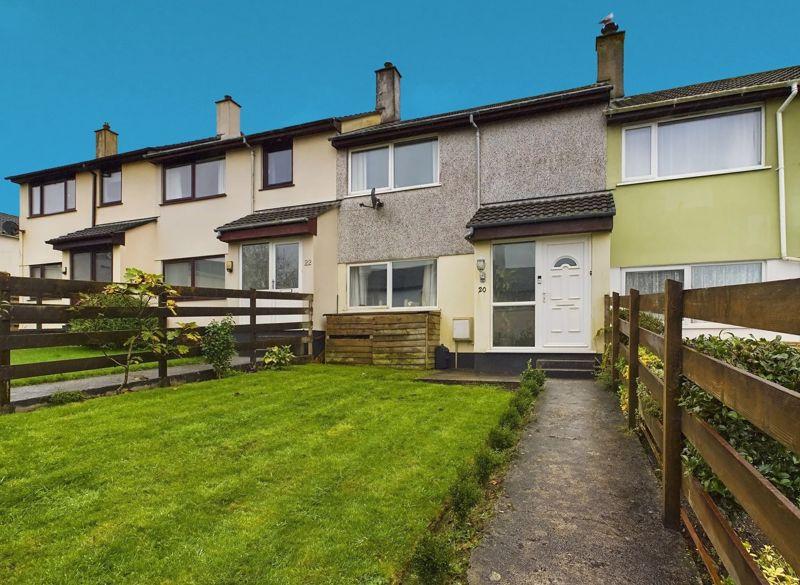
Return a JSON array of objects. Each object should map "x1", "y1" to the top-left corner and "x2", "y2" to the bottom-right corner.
[{"x1": 8, "y1": 96, "x2": 379, "y2": 342}]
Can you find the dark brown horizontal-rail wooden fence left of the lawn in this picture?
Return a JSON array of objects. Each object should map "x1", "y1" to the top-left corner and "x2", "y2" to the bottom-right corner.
[{"x1": 0, "y1": 274, "x2": 313, "y2": 410}]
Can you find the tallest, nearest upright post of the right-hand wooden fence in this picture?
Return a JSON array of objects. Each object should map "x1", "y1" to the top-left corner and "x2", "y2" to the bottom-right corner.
[{"x1": 662, "y1": 280, "x2": 683, "y2": 530}]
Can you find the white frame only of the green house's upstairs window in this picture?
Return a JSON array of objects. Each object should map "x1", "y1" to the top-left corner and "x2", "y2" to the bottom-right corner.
[{"x1": 617, "y1": 103, "x2": 771, "y2": 185}]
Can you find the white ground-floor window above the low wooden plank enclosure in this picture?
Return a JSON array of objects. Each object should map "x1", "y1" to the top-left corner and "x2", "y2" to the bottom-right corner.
[{"x1": 348, "y1": 259, "x2": 437, "y2": 308}]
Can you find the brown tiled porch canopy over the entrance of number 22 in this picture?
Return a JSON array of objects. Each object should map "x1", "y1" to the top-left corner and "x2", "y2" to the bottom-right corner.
[{"x1": 216, "y1": 201, "x2": 339, "y2": 242}]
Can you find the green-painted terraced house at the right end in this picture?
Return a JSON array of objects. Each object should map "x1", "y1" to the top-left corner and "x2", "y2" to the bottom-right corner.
[{"x1": 606, "y1": 40, "x2": 800, "y2": 335}]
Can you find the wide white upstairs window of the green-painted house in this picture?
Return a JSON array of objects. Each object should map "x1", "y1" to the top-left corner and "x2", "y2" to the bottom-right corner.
[{"x1": 622, "y1": 106, "x2": 764, "y2": 182}]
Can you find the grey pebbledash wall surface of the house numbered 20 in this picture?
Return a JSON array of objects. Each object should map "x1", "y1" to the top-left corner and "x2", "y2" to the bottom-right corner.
[{"x1": 336, "y1": 105, "x2": 606, "y2": 263}]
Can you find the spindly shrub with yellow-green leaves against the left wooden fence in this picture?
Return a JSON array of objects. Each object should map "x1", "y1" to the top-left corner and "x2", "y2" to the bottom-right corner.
[{"x1": 72, "y1": 268, "x2": 200, "y2": 391}]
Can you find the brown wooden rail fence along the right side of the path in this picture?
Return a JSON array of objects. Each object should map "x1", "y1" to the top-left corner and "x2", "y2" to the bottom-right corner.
[{"x1": 605, "y1": 279, "x2": 800, "y2": 584}]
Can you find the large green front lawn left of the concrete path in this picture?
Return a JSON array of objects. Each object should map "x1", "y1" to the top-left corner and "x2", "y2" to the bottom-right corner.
[{"x1": 0, "y1": 365, "x2": 512, "y2": 585}]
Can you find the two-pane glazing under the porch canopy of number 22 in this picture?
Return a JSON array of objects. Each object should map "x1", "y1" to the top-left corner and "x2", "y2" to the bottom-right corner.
[{"x1": 242, "y1": 242, "x2": 300, "y2": 290}]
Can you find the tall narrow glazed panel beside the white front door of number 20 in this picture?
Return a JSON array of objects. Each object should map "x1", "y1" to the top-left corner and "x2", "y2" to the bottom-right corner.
[{"x1": 492, "y1": 242, "x2": 536, "y2": 347}]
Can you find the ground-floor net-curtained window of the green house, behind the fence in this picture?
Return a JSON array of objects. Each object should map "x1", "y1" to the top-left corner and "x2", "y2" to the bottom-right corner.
[{"x1": 624, "y1": 262, "x2": 763, "y2": 294}]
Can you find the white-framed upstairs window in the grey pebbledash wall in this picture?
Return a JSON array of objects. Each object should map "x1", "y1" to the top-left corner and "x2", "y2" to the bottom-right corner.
[{"x1": 349, "y1": 137, "x2": 439, "y2": 195}]
